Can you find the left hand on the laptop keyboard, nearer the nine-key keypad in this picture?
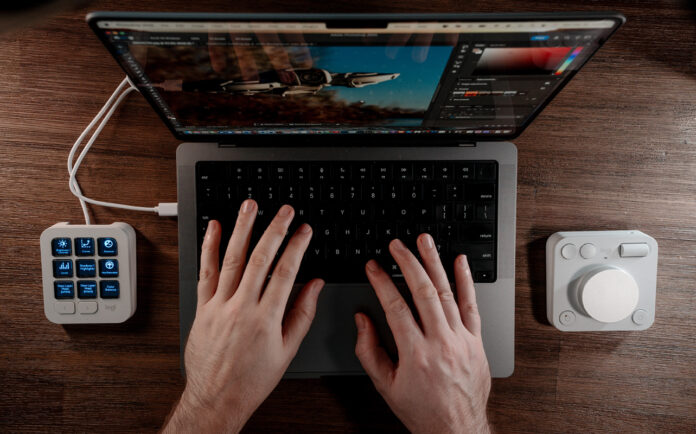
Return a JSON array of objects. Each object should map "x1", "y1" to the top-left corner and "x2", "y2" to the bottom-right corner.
[{"x1": 164, "y1": 200, "x2": 324, "y2": 432}]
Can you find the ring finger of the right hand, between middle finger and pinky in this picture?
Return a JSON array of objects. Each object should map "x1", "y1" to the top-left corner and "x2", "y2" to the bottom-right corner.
[{"x1": 418, "y1": 234, "x2": 462, "y2": 330}]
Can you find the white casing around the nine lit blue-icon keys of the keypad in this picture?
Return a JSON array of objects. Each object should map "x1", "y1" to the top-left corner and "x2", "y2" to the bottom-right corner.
[{"x1": 40, "y1": 222, "x2": 137, "y2": 324}]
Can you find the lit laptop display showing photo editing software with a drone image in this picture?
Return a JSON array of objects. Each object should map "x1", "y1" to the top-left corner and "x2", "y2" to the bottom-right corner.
[{"x1": 93, "y1": 17, "x2": 620, "y2": 140}]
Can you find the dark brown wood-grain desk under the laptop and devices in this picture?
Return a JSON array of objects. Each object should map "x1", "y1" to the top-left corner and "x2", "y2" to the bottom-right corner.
[{"x1": 0, "y1": 0, "x2": 696, "y2": 432}]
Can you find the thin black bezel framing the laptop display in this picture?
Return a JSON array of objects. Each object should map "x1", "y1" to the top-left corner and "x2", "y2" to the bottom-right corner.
[{"x1": 86, "y1": 12, "x2": 626, "y2": 146}]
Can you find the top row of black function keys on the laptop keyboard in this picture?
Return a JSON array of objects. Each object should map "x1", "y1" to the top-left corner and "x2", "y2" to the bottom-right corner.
[{"x1": 197, "y1": 161, "x2": 497, "y2": 183}]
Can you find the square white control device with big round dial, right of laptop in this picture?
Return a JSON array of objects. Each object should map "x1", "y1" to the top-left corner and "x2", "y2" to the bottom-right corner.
[{"x1": 546, "y1": 230, "x2": 657, "y2": 331}]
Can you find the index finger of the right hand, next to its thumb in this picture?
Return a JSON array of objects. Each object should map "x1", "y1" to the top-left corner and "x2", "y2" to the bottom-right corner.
[{"x1": 365, "y1": 260, "x2": 422, "y2": 352}]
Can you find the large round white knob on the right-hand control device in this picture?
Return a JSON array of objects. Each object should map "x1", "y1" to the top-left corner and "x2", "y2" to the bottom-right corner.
[{"x1": 580, "y1": 267, "x2": 639, "y2": 323}]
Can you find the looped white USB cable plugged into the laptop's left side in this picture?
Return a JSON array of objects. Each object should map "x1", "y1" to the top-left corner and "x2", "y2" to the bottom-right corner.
[{"x1": 68, "y1": 77, "x2": 177, "y2": 224}]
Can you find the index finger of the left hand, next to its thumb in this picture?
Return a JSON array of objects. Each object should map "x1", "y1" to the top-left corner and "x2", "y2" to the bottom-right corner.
[{"x1": 261, "y1": 223, "x2": 312, "y2": 318}]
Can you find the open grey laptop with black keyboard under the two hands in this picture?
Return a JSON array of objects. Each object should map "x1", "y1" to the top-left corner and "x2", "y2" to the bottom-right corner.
[{"x1": 87, "y1": 12, "x2": 624, "y2": 378}]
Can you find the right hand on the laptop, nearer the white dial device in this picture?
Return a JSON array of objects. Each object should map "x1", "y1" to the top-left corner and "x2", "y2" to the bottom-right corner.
[{"x1": 355, "y1": 234, "x2": 491, "y2": 433}]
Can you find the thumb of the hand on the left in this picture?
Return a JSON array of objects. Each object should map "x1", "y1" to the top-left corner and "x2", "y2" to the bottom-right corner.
[{"x1": 283, "y1": 279, "x2": 324, "y2": 356}]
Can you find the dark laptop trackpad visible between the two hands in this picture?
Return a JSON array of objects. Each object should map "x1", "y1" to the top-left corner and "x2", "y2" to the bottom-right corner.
[{"x1": 286, "y1": 285, "x2": 400, "y2": 377}]
